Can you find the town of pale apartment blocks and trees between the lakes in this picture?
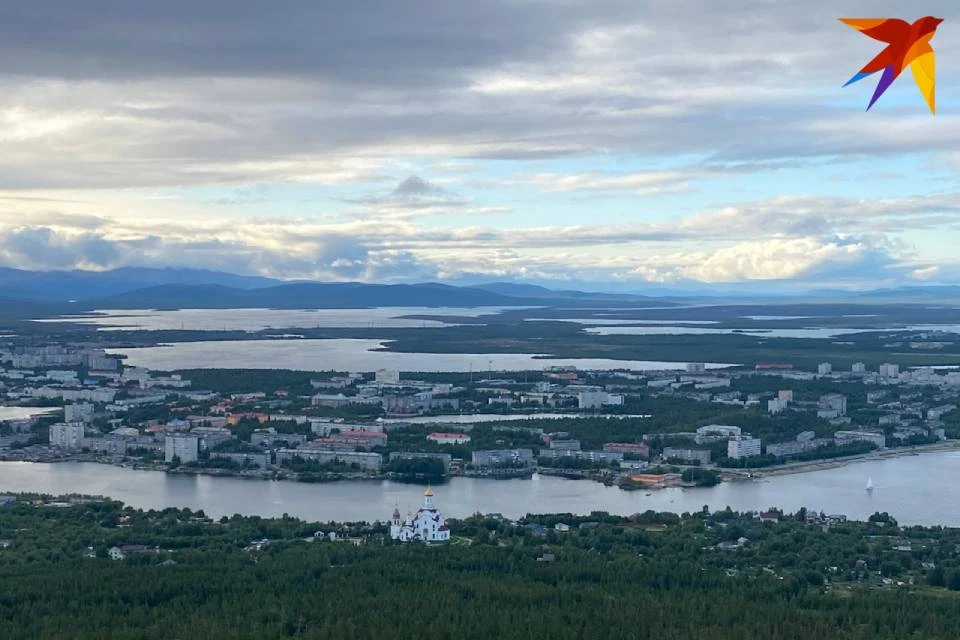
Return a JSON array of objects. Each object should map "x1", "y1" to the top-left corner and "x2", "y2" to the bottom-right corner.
[{"x1": 0, "y1": 343, "x2": 960, "y2": 489}]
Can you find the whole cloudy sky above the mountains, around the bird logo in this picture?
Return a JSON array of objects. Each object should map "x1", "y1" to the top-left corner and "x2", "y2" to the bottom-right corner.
[{"x1": 0, "y1": 0, "x2": 960, "y2": 292}]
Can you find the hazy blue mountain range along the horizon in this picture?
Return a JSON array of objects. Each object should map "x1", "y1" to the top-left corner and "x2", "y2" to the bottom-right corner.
[{"x1": 0, "y1": 267, "x2": 960, "y2": 310}]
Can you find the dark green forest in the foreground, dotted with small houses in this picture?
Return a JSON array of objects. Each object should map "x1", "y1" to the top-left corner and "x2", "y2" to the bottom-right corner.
[{"x1": 0, "y1": 496, "x2": 960, "y2": 640}]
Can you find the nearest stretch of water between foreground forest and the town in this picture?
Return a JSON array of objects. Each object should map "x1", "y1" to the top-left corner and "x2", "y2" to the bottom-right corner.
[{"x1": 0, "y1": 451, "x2": 960, "y2": 527}]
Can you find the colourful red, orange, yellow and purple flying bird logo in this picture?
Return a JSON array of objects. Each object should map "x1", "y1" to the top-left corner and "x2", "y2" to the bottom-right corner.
[{"x1": 840, "y1": 16, "x2": 943, "y2": 114}]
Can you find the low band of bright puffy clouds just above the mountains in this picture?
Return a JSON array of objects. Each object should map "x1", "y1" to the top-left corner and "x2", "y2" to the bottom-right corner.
[{"x1": 0, "y1": 192, "x2": 938, "y2": 286}]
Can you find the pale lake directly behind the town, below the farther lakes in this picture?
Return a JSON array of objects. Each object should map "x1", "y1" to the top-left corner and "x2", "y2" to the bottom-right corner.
[{"x1": 107, "y1": 338, "x2": 730, "y2": 373}]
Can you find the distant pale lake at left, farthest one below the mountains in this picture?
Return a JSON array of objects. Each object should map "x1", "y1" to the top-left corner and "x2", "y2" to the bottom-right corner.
[{"x1": 37, "y1": 307, "x2": 528, "y2": 331}]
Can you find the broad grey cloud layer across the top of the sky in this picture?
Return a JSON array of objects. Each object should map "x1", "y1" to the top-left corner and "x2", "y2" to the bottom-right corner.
[{"x1": 0, "y1": 0, "x2": 960, "y2": 189}]
